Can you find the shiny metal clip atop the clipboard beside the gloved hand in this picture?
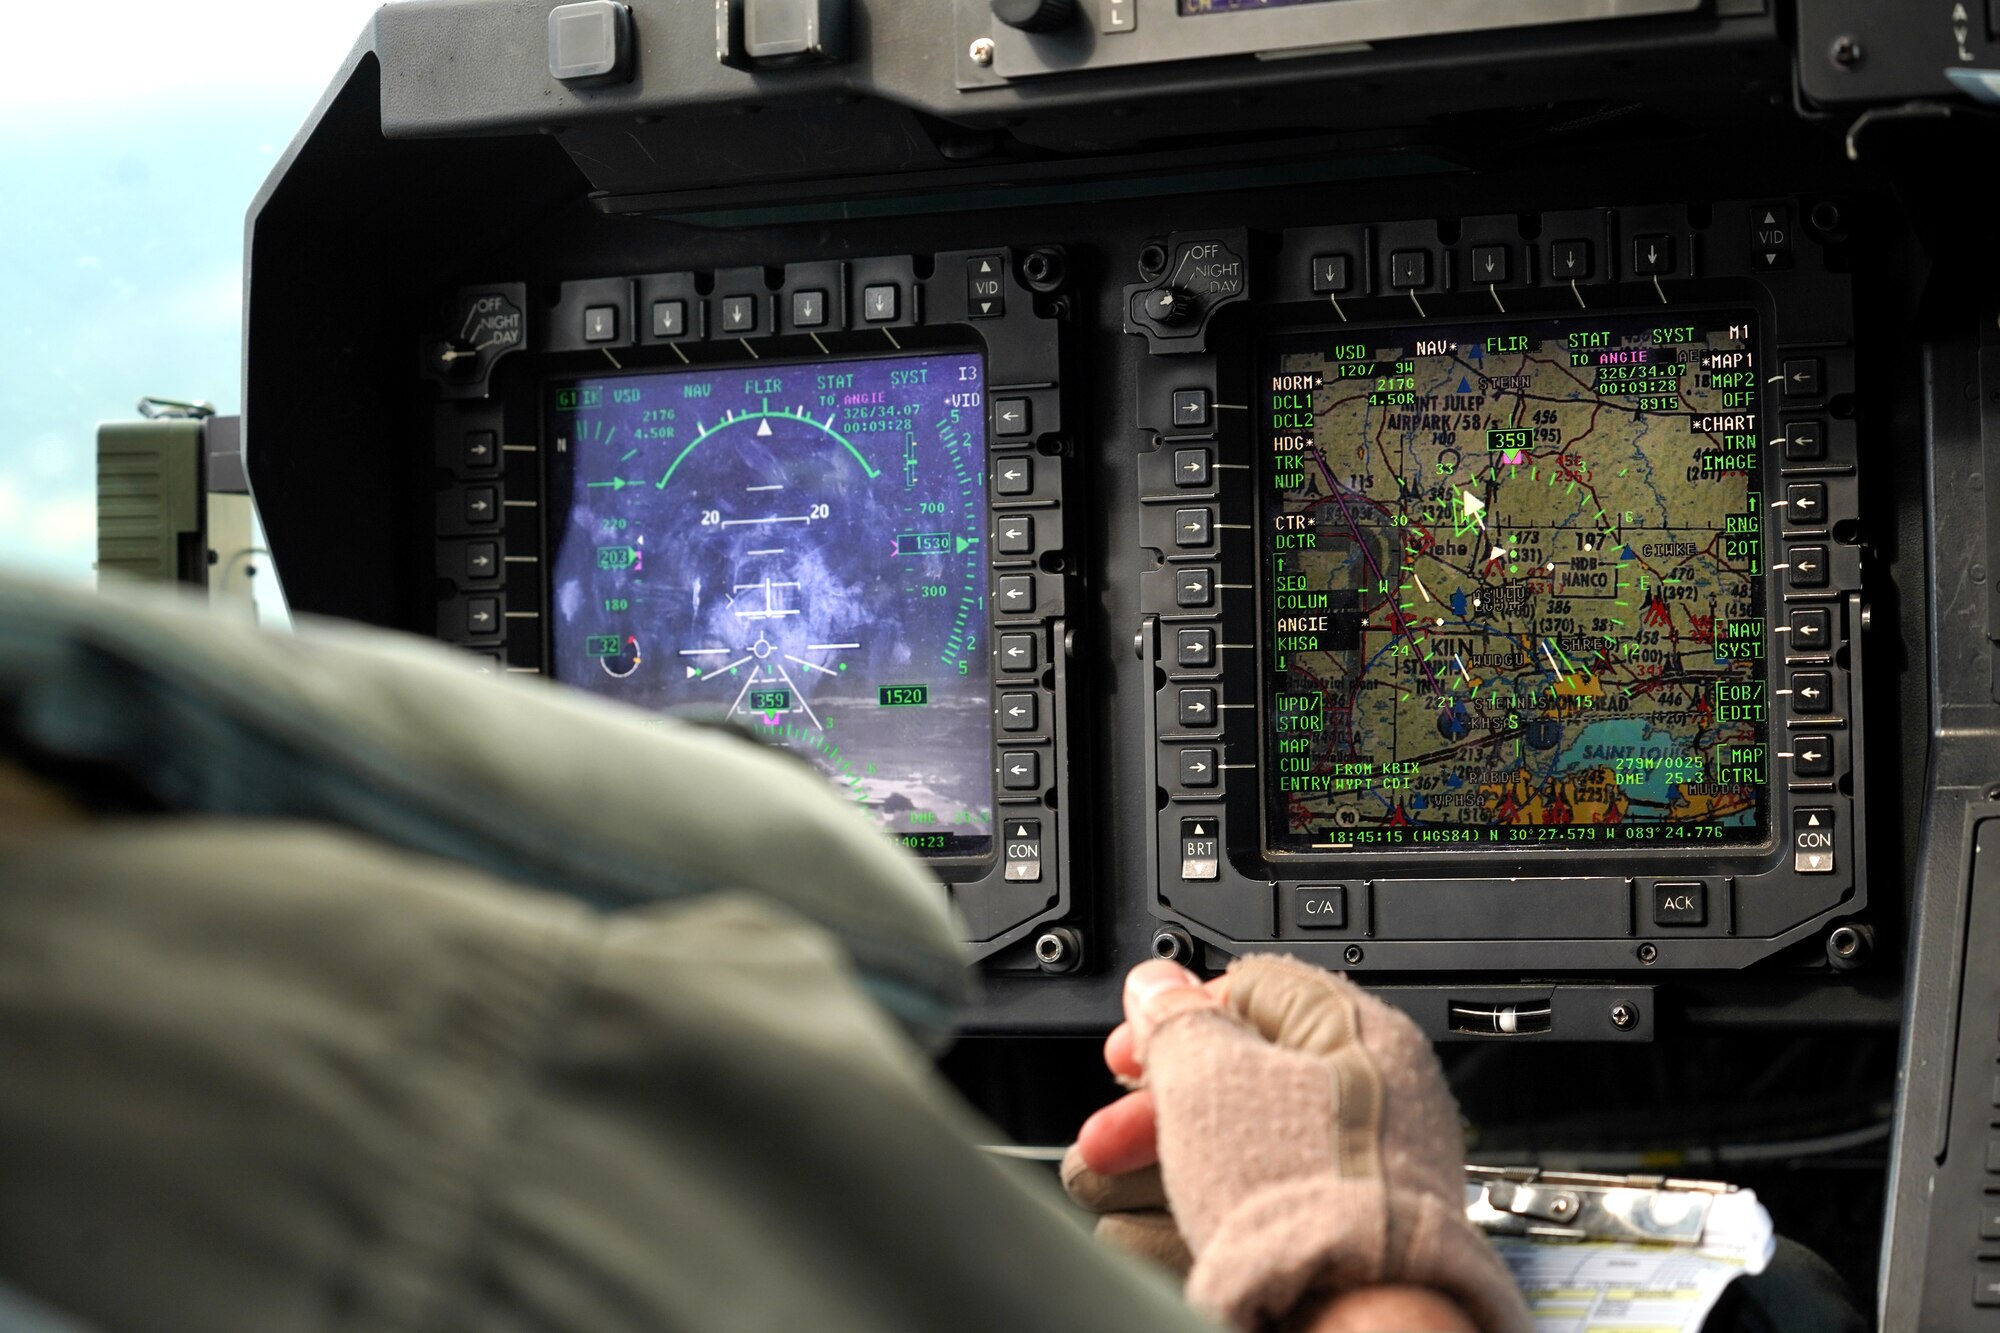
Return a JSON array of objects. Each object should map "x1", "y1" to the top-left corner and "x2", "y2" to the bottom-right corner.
[{"x1": 1466, "y1": 1167, "x2": 1736, "y2": 1245}]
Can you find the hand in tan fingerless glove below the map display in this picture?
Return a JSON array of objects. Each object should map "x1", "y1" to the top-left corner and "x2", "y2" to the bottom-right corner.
[{"x1": 1064, "y1": 955, "x2": 1530, "y2": 1333}]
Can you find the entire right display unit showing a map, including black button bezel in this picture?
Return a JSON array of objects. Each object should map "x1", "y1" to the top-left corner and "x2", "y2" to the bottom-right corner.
[{"x1": 1124, "y1": 200, "x2": 1866, "y2": 971}]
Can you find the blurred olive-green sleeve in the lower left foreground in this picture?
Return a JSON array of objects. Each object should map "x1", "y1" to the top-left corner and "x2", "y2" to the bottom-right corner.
[{"x1": 0, "y1": 819, "x2": 1210, "y2": 1333}]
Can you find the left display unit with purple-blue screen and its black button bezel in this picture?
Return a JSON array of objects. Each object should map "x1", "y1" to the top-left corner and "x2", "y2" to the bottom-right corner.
[{"x1": 422, "y1": 248, "x2": 1086, "y2": 956}]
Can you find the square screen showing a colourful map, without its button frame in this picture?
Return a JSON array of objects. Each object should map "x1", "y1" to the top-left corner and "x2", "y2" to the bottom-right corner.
[{"x1": 1258, "y1": 312, "x2": 1770, "y2": 853}]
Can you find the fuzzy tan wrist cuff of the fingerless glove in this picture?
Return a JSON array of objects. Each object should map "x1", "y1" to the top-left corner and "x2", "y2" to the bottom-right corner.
[{"x1": 1188, "y1": 1175, "x2": 1532, "y2": 1333}]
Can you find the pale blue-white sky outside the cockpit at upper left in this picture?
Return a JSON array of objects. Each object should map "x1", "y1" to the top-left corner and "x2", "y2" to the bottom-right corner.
[{"x1": 0, "y1": 0, "x2": 376, "y2": 578}]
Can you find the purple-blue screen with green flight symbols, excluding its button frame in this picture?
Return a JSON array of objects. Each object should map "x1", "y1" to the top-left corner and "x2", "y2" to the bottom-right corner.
[{"x1": 546, "y1": 352, "x2": 992, "y2": 857}]
